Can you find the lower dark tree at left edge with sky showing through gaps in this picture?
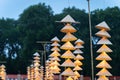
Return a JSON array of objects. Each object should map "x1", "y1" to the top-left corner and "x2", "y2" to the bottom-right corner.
[{"x1": 0, "y1": 18, "x2": 20, "y2": 73}]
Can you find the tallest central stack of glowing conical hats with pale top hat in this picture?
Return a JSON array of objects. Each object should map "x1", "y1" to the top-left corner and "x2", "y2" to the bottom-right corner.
[{"x1": 59, "y1": 15, "x2": 78, "y2": 80}]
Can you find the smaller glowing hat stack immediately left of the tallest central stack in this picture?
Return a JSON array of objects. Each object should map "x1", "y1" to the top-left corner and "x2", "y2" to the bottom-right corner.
[{"x1": 50, "y1": 37, "x2": 60, "y2": 74}]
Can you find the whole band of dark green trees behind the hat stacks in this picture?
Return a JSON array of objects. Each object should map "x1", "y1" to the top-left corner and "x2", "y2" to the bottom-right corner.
[{"x1": 0, "y1": 3, "x2": 120, "y2": 76}]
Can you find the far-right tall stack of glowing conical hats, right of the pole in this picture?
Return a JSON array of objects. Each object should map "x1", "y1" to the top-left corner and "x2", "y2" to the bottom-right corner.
[{"x1": 96, "y1": 21, "x2": 112, "y2": 80}]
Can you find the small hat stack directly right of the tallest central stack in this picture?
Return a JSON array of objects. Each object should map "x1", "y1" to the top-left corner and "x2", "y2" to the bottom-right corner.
[{"x1": 73, "y1": 39, "x2": 84, "y2": 80}]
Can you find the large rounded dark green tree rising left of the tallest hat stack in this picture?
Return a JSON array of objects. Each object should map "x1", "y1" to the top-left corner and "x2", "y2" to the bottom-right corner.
[{"x1": 19, "y1": 3, "x2": 53, "y2": 73}]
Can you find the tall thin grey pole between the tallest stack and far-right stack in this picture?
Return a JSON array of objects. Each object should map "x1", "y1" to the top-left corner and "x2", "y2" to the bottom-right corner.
[{"x1": 87, "y1": 0, "x2": 94, "y2": 80}]
